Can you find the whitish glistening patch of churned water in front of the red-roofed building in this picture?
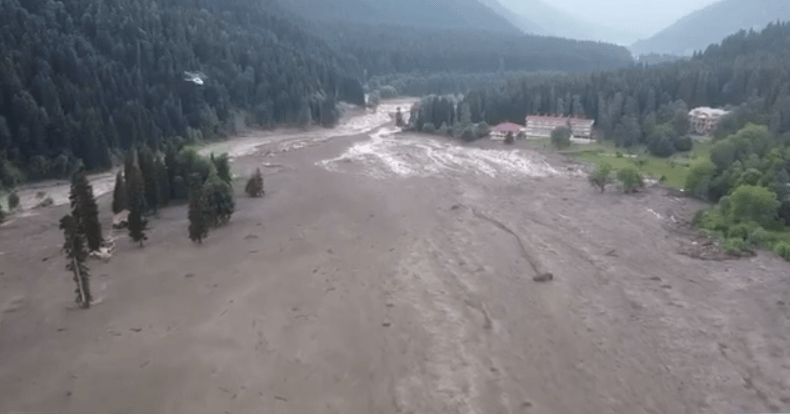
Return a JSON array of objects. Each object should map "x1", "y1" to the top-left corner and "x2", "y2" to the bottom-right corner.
[{"x1": 318, "y1": 128, "x2": 559, "y2": 178}]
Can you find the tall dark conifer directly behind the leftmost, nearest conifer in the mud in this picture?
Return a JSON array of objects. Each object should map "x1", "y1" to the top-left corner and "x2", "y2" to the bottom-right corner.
[{"x1": 69, "y1": 169, "x2": 103, "y2": 251}]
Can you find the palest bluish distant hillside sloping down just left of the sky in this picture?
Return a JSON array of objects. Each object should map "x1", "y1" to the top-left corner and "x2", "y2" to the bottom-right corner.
[{"x1": 496, "y1": 0, "x2": 636, "y2": 44}]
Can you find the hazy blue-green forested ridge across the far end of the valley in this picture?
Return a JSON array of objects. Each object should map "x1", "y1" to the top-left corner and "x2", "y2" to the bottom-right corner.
[{"x1": 314, "y1": 23, "x2": 633, "y2": 76}]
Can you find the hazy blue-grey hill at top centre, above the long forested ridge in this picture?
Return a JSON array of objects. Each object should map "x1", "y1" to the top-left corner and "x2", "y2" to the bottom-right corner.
[{"x1": 281, "y1": 0, "x2": 520, "y2": 34}]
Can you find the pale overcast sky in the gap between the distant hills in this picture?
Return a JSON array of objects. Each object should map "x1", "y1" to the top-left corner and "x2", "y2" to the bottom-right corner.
[{"x1": 543, "y1": 0, "x2": 718, "y2": 36}]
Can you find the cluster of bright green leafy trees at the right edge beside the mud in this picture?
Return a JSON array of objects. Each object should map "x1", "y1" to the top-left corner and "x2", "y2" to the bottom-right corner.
[{"x1": 685, "y1": 119, "x2": 790, "y2": 259}]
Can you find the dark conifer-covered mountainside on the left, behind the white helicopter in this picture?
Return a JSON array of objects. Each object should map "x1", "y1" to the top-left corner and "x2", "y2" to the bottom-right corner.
[{"x1": 0, "y1": 0, "x2": 364, "y2": 184}]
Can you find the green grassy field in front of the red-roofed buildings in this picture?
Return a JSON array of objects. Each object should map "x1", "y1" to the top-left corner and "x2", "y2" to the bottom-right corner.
[{"x1": 528, "y1": 138, "x2": 713, "y2": 188}]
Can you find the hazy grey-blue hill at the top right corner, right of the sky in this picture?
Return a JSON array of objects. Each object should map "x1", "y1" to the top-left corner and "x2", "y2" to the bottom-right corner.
[{"x1": 631, "y1": 0, "x2": 790, "y2": 55}]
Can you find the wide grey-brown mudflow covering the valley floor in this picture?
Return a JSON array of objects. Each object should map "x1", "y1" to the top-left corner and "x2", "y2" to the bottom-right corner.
[{"x1": 0, "y1": 101, "x2": 790, "y2": 414}]
